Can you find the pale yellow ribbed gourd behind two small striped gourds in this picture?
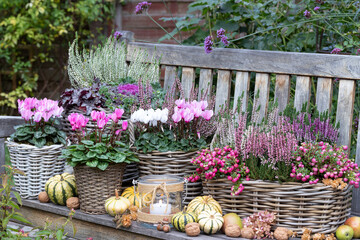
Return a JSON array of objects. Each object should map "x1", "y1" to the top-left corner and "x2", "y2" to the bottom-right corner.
[{"x1": 187, "y1": 195, "x2": 222, "y2": 216}]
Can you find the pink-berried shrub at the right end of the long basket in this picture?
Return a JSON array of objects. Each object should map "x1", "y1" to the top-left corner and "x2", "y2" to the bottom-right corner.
[{"x1": 290, "y1": 142, "x2": 360, "y2": 188}]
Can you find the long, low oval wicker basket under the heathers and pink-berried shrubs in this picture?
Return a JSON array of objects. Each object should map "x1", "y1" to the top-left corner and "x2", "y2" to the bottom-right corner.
[{"x1": 203, "y1": 179, "x2": 352, "y2": 234}]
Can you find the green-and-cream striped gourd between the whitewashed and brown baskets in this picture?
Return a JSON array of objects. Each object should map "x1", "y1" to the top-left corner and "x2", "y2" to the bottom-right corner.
[{"x1": 45, "y1": 173, "x2": 77, "y2": 206}]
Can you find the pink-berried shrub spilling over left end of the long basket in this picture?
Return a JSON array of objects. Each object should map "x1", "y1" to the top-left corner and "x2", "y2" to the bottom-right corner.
[{"x1": 187, "y1": 146, "x2": 250, "y2": 195}]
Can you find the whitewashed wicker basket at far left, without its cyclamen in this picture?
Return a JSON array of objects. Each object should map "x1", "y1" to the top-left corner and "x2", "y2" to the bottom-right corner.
[{"x1": 6, "y1": 139, "x2": 65, "y2": 199}]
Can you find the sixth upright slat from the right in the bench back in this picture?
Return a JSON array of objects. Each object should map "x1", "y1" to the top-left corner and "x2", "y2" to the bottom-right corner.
[{"x1": 234, "y1": 72, "x2": 250, "y2": 112}]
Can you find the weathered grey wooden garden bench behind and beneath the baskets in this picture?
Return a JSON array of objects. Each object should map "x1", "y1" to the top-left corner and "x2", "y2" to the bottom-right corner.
[{"x1": 0, "y1": 32, "x2": 360, "y2": 239}]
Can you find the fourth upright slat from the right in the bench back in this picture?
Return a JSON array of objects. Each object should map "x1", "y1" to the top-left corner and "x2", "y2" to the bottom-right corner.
[{"x1": 275, "y1": 74, "x2": 291, "y2": 112}]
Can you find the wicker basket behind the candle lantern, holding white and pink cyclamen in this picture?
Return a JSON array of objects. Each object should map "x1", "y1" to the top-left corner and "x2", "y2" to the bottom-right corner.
[{"x1": 136, "y1": 151, "x2": 202, "y2": 205}]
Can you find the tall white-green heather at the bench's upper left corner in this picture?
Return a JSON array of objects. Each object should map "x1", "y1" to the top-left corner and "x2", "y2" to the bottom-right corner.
[{"x1": 68, "y1": 36, "x2": 160, "y2": 88}]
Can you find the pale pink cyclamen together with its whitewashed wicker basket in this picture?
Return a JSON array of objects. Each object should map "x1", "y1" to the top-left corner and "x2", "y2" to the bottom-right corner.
[{"x1": 6, "y1": 98, "x2": 66, "y2": 199}]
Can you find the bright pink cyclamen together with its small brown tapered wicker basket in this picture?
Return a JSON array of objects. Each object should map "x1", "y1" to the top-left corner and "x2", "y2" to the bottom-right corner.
[{"x1": 62, "y1": 109, "x2": 139, "y2": 214}]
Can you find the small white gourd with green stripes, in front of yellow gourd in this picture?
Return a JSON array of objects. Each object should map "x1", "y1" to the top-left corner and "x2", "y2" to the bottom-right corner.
[{"x1": 199, "y1": 210, "x2": 224, "y2": 234}]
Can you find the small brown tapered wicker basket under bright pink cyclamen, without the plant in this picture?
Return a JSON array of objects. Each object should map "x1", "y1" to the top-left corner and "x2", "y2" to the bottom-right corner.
[{"x1": 74, "y1": 163, "x2": 126, "y2": 214}]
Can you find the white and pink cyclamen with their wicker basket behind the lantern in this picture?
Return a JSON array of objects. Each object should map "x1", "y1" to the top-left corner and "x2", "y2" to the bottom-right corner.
[{"x1": 130, "y1": 79, "x2": 215, "y2": 201}]
